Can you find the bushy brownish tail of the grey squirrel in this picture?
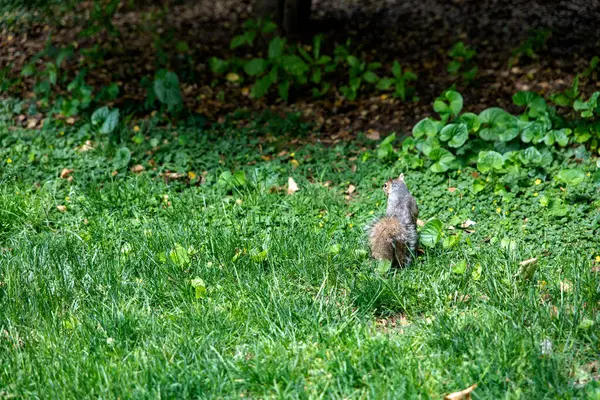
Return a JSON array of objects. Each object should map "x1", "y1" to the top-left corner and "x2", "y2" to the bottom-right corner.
[{"x1": 369, "y1": 217, "x2": 417, "y2": 267}]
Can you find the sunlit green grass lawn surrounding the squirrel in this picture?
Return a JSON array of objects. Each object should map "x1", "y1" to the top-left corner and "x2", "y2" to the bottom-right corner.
[{"x1": 0, "y1": 108, "x2": 600, "y2": 399}]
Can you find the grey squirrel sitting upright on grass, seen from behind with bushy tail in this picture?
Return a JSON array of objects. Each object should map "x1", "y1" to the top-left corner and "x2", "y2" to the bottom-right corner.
[{"x1": 368, "y1": 174, "x2": 419, "y2": 268}]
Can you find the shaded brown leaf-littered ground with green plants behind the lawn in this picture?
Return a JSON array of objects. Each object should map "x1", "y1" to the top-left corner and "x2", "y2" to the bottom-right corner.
[{"x1": 0, "y1": 0, "x2": 600, "y2": 136}]
